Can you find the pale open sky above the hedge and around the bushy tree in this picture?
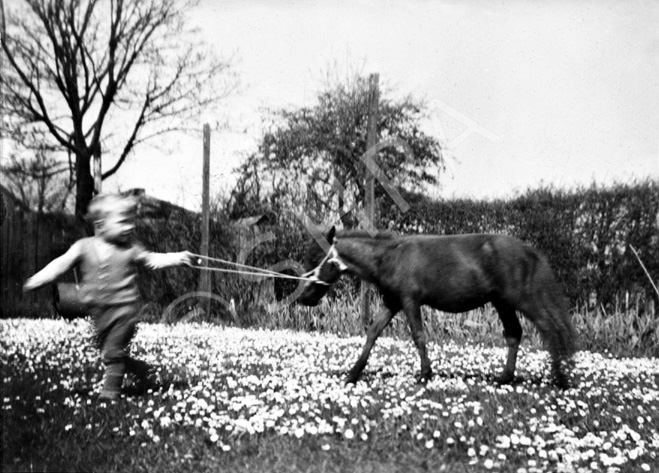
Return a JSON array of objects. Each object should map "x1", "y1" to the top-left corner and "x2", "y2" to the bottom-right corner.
[{"x1": 104, "y1": 0, "x2": 659, "y2": 208}]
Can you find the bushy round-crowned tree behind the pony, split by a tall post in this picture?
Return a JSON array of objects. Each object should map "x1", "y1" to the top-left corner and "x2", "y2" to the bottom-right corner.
[{"x1": 230, "y1": 74, "x2": 443, "y2": 226}]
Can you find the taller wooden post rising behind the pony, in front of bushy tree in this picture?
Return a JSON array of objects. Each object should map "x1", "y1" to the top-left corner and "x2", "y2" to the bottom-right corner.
[{"x1": 360, "y1": 74, "x2": 380, "y2": 330}]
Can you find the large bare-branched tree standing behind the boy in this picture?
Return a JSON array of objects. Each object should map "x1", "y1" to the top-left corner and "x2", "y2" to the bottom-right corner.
[{"x1": 0, "y1": 0, "x2": 236, "y2": 215}]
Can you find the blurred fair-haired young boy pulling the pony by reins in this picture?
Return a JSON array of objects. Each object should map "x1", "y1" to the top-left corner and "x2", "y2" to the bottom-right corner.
[{"x1": 23, "y1": 194, "x2": 192, "y2": 401}]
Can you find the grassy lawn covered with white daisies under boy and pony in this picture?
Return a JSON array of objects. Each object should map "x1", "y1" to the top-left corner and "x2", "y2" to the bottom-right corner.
[{"x1": 0, "y1": 319, "x2": 659, "y2": 473}]
